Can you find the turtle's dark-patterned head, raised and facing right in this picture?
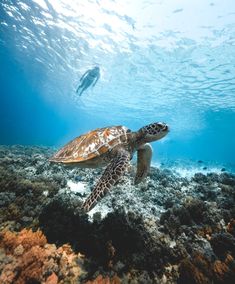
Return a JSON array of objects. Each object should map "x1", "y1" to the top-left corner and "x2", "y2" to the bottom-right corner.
[{"x1": 138, "y1": 122, "x2": 169, "y2": 143}]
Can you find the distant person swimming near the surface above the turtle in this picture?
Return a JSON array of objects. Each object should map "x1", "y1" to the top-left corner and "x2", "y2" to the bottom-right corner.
[{"x1": 76, "y1": 66, "x2": 100, "y2": 96}]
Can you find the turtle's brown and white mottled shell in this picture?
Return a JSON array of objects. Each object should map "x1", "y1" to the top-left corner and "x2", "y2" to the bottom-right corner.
[{"x1": 50, "y1": 126, "x2": 128, "y2": 164}]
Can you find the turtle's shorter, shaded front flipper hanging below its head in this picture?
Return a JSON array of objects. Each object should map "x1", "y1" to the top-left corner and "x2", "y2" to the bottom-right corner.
[{"x1": 135, "y1": 143, "x2": 153, "y2": 184}]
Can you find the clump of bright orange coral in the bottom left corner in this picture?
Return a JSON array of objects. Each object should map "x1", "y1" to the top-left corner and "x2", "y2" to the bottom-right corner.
[{"x1": 0, "y1": 229, "x2": 82, "y2": 284}]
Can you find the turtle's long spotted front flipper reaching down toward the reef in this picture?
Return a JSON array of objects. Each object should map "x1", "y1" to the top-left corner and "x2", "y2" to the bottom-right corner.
[{"x1": 82, "y1": 151, "x2": 130, "y2": 212}]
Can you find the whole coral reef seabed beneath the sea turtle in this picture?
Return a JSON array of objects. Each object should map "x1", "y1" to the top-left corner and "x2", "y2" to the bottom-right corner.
[{"x1": 0, "y1": 145, "x2": 235, "y2": 284}]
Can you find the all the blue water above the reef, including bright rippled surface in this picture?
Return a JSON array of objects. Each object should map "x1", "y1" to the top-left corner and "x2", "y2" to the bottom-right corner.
[{"x1": 0, "y1": 0, "x2": 235, "y2": 168}]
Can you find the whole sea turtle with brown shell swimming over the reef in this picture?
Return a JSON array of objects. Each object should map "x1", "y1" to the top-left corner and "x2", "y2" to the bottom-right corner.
[{"x1": 50, "y1": 122, "x2": 169, "y2": 212}]
